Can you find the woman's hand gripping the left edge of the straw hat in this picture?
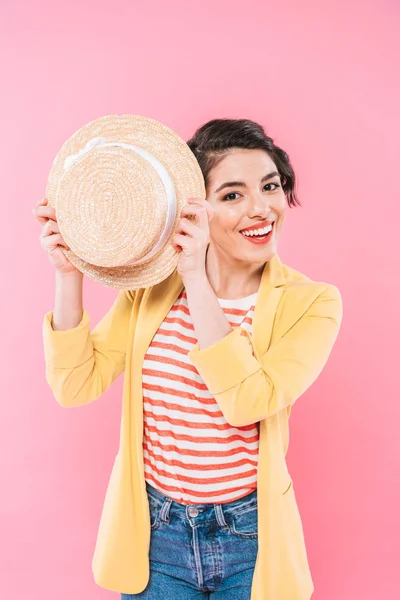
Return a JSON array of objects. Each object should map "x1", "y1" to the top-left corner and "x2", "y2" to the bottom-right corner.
[{"x1": 33, "y1": 198, "x2": 83, "y2": 275}]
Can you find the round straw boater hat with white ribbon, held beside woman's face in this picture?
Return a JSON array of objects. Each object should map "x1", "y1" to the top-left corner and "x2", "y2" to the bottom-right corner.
[{"x1": 46, "y1": 115, "x2": 206, "y2": 290}]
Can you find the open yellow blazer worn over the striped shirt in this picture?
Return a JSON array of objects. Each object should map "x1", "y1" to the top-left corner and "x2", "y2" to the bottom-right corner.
[{"x1": 43, "y1": 254, "x2": 342, "y2": 600}]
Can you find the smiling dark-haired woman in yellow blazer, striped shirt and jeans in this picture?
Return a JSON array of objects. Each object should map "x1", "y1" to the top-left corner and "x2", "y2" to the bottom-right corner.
[{"x1": 35, "y1": 119, "x2": 342, "y2": 600}]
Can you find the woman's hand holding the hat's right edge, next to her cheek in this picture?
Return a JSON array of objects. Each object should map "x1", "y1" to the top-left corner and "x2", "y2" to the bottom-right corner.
[{"x1": 171, "y1": 198, "x2": 214, "y2": 281}]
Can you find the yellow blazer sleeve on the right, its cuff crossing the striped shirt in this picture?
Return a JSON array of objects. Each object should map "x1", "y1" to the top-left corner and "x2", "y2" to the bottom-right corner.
[{"x1": 188, "y1": 284, "x2": 343, "y2": 427}]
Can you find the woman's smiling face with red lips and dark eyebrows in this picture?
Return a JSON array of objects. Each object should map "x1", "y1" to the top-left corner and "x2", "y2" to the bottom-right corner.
[{"x1": 207, "y1": 149, "x2": 286, "y2": 263}]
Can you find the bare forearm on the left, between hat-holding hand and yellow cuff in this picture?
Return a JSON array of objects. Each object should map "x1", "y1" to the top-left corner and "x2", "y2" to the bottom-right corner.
[{"x1": 52, "y1": 271, "x2": 83, "y2": 331}]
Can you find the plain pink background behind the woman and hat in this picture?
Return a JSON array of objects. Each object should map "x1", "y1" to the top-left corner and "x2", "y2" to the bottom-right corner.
[{"x1": 0, "y1": 0, "x2": 400, "y2": 600}]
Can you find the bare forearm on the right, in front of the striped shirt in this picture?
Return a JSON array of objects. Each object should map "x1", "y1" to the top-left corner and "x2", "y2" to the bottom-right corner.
[{"x1": 185, "y1": 273, "x2": 232, "y2": 350}]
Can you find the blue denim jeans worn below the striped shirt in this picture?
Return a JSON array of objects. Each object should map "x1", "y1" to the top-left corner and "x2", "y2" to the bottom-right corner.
[{"x1": 121, "y1": 482, "x2": 258, "y2": 600}]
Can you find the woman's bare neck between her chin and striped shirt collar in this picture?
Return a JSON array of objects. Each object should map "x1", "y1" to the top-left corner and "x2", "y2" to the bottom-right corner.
[{"x1": 206, "y1": 243, "x2": 265, "y2": 300}]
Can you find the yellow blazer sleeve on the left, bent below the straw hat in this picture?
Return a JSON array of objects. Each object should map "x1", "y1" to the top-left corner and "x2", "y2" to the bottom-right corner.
[{"x1": 43, "y1": 290, "x2": 134, "y2": 407}]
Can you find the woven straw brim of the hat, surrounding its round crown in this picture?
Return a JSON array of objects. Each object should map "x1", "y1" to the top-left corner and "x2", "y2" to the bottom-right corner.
[{"x1": 46, "y1": 114, "x2": 206, "y2": 290}]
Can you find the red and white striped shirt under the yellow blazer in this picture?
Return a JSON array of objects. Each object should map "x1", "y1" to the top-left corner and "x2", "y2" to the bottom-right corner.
[{"x1": 142, "y1": 290, "x2": 259, "y2": 504}]
